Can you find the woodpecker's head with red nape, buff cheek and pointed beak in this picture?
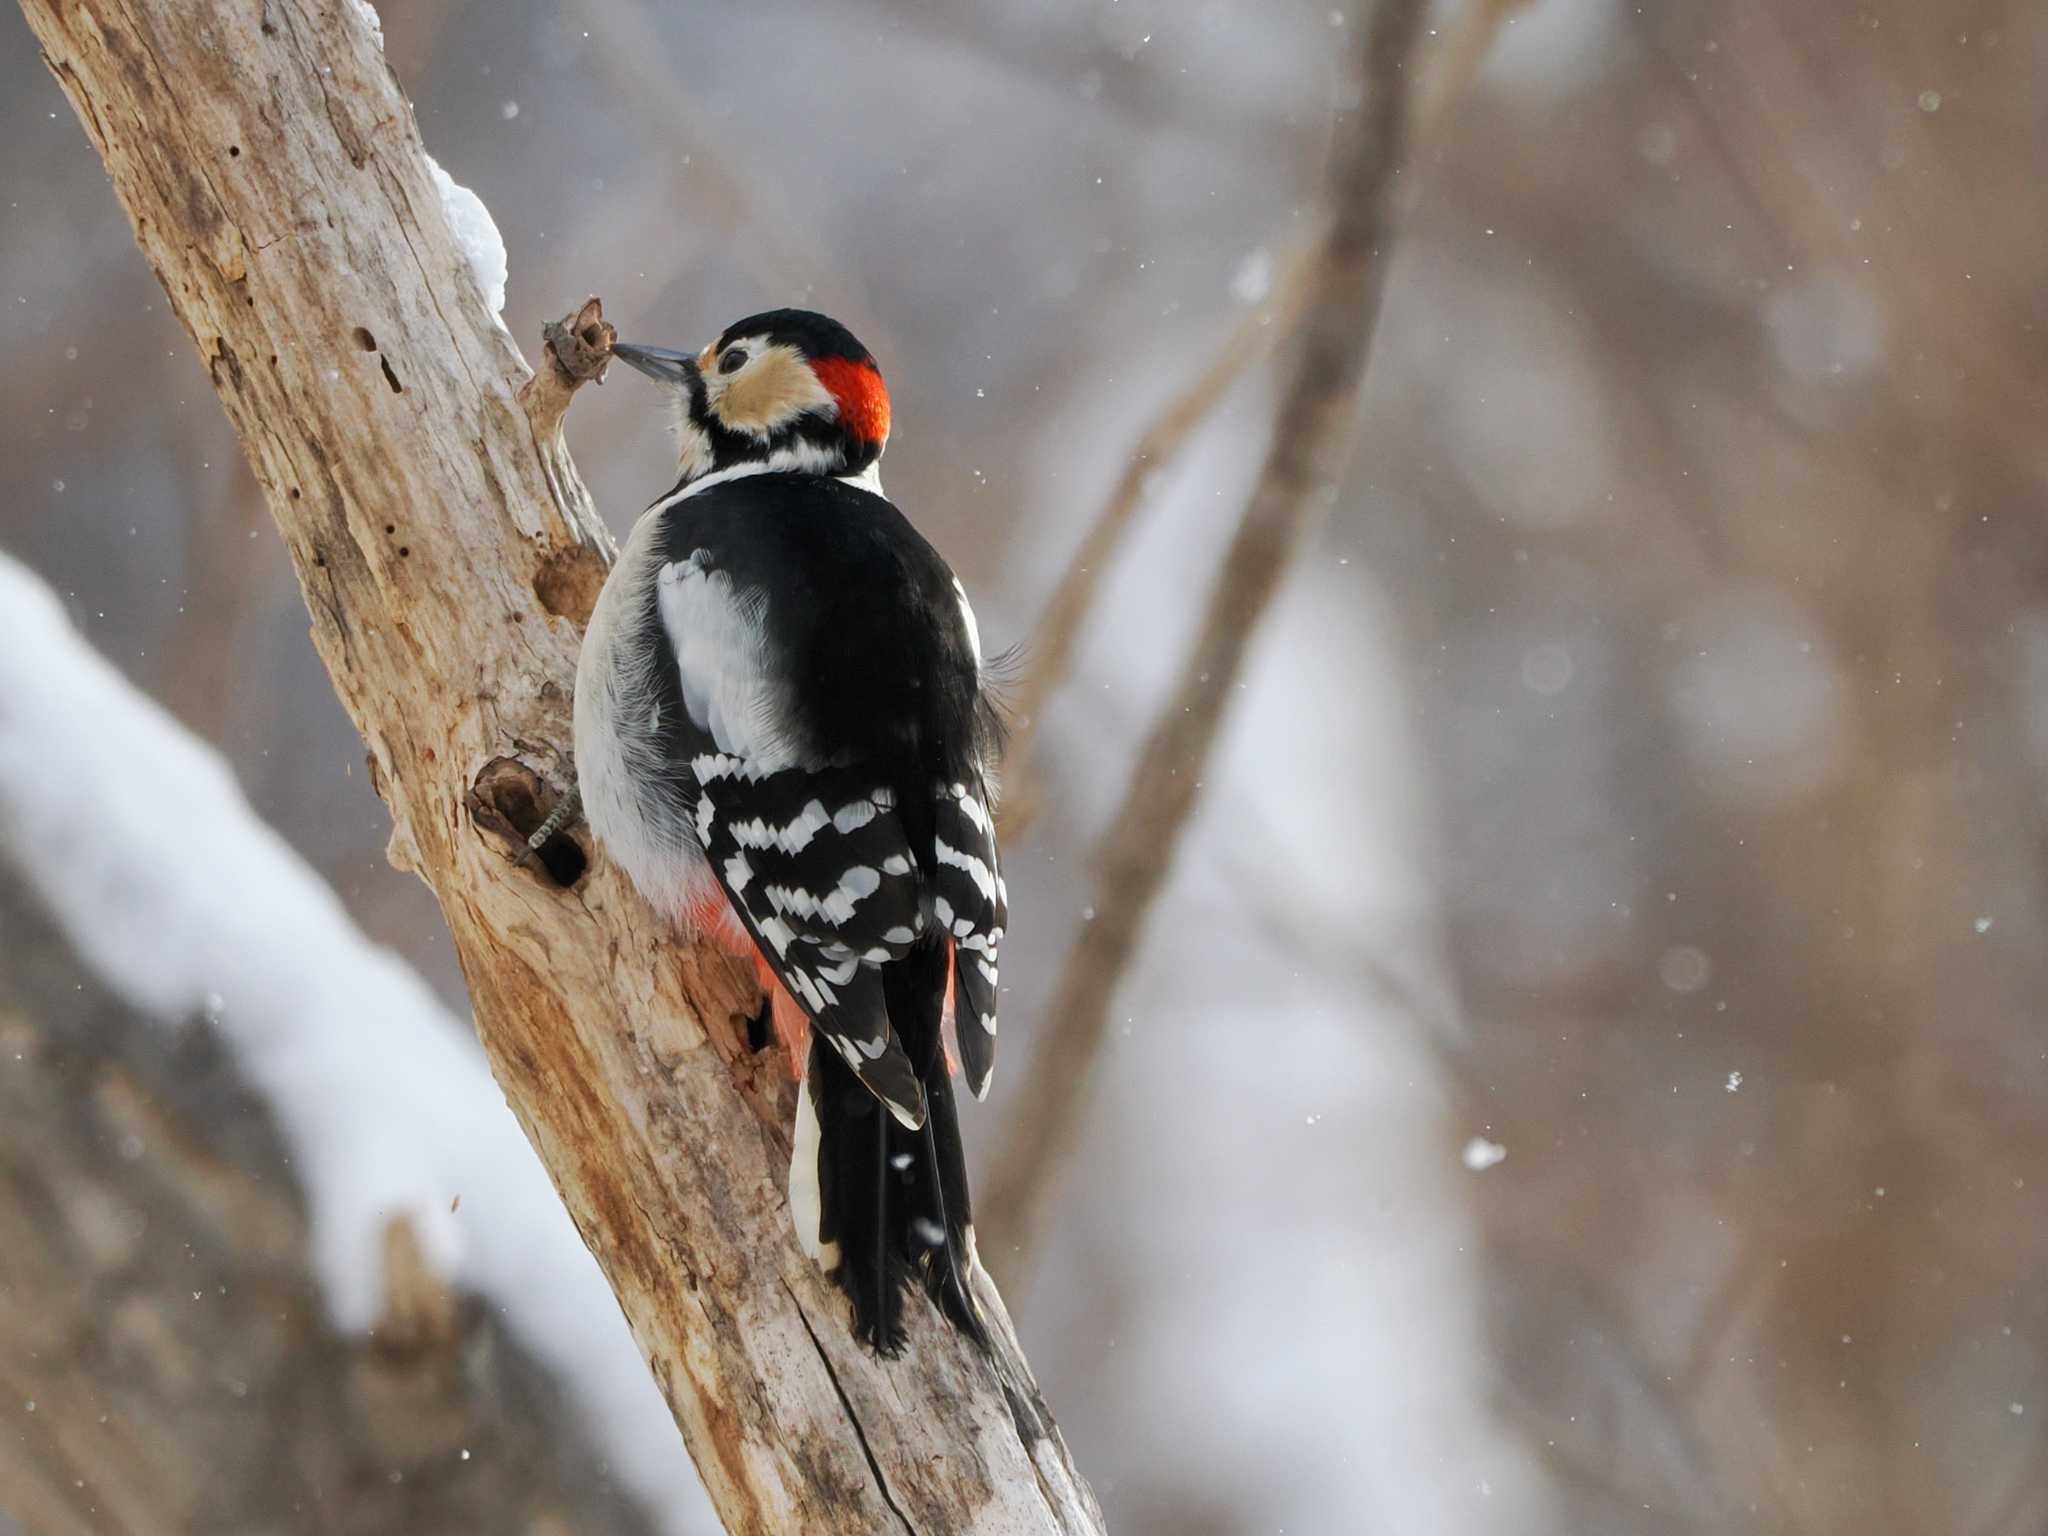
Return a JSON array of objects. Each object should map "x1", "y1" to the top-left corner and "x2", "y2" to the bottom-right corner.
[{"x1": 612, "y1": 309, "x2": 889, "y2": 495}]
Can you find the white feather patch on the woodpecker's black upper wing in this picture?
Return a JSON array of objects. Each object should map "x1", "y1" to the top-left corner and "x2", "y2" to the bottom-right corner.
[{"x1": 655, "y1": 549, "x2": 793, "y2": 774}]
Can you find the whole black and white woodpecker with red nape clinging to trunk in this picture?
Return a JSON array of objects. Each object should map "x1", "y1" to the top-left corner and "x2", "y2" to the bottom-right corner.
[{"x1": 575, "y1": 309, "x2": 1006, "y2": 1354}]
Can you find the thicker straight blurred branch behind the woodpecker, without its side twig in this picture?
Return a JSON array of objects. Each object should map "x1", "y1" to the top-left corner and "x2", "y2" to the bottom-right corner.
[{"x1": 983, "y1": 0, "x2": 1421, "y2": 1257}]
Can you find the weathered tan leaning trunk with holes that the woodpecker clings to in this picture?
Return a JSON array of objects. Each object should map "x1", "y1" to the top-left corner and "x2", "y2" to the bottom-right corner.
[{"x1": 23, "y1": 0, "x2": 1100, "y2": 1532}]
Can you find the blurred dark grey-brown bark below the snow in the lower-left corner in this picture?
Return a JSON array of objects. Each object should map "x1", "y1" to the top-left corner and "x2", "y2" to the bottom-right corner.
[{"x1": 0, "y1": 874, "x2": 649, "y2": 1536}]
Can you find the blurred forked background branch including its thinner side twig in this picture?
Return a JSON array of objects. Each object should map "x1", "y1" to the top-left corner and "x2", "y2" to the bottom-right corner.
[{"x1": 983, "y1": 0, "x2": 1509, "y2": 1276}]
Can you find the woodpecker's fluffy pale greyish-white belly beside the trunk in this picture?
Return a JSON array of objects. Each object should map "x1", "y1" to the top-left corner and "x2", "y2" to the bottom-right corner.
[{"x1": 575, "y1": 516, "x2": 717, "y2": 920}]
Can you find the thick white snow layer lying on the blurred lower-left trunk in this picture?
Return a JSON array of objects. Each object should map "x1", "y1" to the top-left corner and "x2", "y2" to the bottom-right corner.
[{"x1": 0, "y1": 553, "x2": 717, "y2": 1532}]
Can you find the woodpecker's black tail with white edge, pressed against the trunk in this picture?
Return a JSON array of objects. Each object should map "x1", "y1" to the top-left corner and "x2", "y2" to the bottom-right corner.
[{"x1": 788, "y1": 944, "x2": 987, "y2": 1354}]
